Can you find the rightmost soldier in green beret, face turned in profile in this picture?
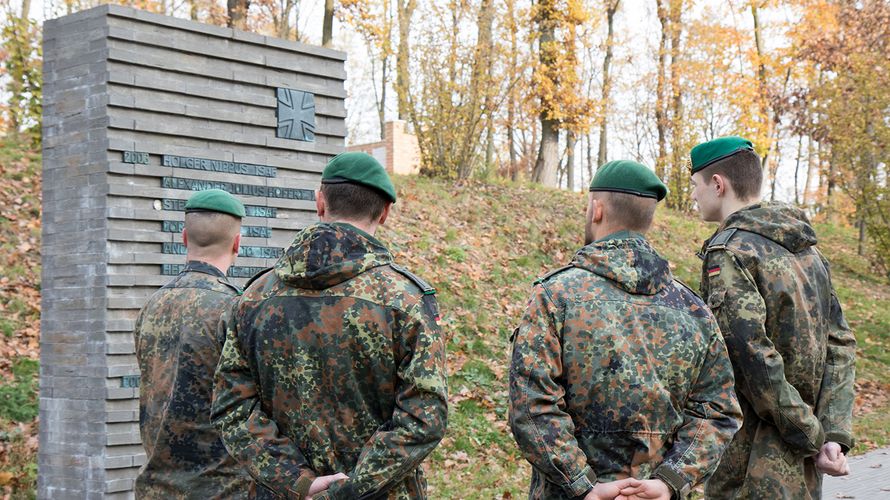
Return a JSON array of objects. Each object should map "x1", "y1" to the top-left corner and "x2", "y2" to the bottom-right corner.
[{"x1": 691, "y1": 137, "x2": 856, "y2": 499}]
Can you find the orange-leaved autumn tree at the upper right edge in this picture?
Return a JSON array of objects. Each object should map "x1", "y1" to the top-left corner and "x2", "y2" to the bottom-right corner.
[{"x1": 795, "y1": 0, "x2": 890, "y2": 276}]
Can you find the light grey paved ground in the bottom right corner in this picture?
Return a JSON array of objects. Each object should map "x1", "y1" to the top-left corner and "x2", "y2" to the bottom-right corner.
[{"x1": 822, "y1": 448, "x2": 890, "y2": 500}]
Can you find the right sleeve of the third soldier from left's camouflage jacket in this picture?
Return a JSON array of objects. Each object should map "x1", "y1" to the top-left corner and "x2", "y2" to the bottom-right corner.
[{"x1": 653, "y1": 324, "x2": 742, "y2": 498}]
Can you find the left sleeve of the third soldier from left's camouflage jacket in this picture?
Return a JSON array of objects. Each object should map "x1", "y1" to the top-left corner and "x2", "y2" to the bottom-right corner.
[{"x1": 510, "y1": 285, "x2": 596, "y2": 497}]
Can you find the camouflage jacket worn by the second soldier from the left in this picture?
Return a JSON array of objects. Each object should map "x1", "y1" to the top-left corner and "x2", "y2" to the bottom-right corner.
[{"x1": 212, "y1": 223, "x2": 448, "y2": 500}]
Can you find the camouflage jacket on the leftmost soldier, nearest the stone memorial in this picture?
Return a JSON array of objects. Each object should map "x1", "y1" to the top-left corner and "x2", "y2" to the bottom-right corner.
[{"x1": 134, "y1": 261, "x2": 253, "y2": 500}]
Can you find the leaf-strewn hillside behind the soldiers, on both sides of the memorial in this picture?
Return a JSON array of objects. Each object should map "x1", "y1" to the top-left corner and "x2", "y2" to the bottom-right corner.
[{"x1": 0, "y1": 140, "x2": 890, "y2": 498}]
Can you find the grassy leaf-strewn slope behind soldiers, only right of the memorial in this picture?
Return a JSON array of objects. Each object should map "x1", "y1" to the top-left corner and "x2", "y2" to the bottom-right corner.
[{"x1": 380, "y1": 177, "x2": 890, "y2": 498}]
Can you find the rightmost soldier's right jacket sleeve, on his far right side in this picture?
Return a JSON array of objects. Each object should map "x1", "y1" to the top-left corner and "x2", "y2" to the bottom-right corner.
[{"x1": 816, "y1": 258, "x2": 856, "y2": 453}]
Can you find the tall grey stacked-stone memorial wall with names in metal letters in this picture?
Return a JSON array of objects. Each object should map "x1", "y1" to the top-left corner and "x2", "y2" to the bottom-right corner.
[{"x1": 38, "y1": 5, "x2": 346, "y2": 498}]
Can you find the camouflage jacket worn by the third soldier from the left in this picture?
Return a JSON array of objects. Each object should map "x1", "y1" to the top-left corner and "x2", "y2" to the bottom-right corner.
[{"x1": 510, "y1": 232, "x2": 741, "y2": 499}]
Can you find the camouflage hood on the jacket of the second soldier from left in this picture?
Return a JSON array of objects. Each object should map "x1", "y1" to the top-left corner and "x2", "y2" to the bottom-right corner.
[{"x1": 274, "y1": 222, "x2": 392, "y2": 290}]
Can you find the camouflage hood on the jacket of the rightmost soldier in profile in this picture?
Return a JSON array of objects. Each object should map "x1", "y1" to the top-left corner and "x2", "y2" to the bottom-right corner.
[{"x1": 717, "y1": 203, "x2": 816, "y2": 253}]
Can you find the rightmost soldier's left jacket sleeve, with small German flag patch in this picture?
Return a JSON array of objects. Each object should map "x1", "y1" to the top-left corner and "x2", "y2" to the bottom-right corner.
[{"x1": 708, "y1": 250, "x2": 825, "y2": 456}]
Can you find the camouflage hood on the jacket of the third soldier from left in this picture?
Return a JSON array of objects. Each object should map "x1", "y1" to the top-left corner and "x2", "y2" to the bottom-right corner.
[{"x1": 572, "y1": 238, "x2": 673, "y2": 295}]
